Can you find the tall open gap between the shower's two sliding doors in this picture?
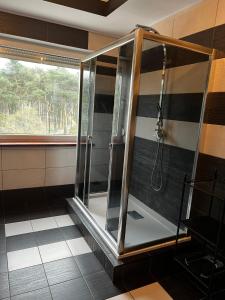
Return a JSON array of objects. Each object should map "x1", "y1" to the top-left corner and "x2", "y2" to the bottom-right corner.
[{"x1": 85, "y1": 49, "x2": 118, "y2": 229}]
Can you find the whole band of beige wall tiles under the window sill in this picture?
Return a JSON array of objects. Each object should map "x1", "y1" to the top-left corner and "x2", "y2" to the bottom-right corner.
[{"x1": 0, "y1": 147, "x2": 76, "y2": 190}]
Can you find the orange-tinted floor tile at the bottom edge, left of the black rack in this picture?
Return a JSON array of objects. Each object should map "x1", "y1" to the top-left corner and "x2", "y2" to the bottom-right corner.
[{"x1": 130, "y1": 282, "x2": 173, "y2": 300}]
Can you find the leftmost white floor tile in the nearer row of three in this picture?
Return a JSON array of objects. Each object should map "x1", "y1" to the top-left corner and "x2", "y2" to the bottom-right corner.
[{"x1": 7, "y1": 247, "x2": 42, "y2": 271}]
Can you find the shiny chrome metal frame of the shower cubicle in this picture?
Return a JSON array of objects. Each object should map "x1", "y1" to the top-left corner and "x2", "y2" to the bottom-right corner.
[{"x1": 74, "y1": 28, "x2": 216, "y2": 258}]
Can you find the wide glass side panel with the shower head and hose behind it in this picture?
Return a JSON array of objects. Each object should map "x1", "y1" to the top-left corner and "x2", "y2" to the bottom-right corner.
[{"x1": 125, "y1": 40, "x2": 209, "y2": 248}]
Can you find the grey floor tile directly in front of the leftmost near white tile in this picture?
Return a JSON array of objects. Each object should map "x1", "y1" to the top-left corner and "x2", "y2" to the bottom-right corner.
[{"x1": 9, "y1": 265, "x2": 48, "y2": 296}]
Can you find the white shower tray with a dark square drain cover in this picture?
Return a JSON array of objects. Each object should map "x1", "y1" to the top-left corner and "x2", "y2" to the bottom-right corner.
[{"x1": 89, "y1": 195, "x2": 177, "y2": 247}]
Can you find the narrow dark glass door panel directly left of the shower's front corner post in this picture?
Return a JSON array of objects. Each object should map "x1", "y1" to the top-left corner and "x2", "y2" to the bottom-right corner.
[{"x1": 106, "y1": 42, "x2": 134, "y2": 240}]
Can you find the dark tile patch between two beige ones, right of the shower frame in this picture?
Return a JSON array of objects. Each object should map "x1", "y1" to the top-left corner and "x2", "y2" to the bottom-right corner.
[{"x1": 204, "y1": 92, "x2": 225, "y2": 125}]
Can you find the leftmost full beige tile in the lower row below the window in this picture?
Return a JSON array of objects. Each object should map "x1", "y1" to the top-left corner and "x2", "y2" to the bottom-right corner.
[{"x1": 2, "y1": 169, "x2": 45, "y2": 190}]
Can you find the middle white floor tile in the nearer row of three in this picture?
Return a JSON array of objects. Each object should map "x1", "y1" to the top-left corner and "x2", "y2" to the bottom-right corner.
[{"x1": 39, "y1": 242, "x2": 72, "y2": 263}]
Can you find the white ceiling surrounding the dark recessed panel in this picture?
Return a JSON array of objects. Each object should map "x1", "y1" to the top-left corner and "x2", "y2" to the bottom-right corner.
[{"x1": 0, "y1": 0, "x2": 201, "y2": 36}]
